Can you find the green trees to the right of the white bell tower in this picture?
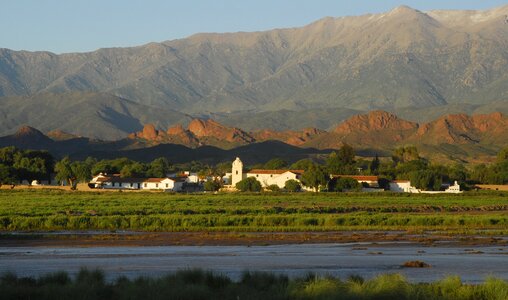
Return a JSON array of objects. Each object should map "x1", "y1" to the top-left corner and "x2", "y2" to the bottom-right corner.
[{"x1": 244, "y1": 144, "x2": 508, "y2": 191}]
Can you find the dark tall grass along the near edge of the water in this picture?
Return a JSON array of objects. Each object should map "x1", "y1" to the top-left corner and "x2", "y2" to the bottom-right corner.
[{"x1": 0, "y1": 269, "x2": 508, "y2": 300}]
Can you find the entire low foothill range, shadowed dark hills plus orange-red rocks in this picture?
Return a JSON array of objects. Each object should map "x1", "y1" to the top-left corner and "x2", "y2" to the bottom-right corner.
[{"x1": 0, "y1": 111, "x2": 508, "y2": 162}]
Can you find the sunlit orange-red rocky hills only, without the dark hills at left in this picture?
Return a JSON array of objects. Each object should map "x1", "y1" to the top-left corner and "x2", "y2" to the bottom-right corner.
[{"x1": 124, "y1": 111, "x2": 508, "y2": 160}]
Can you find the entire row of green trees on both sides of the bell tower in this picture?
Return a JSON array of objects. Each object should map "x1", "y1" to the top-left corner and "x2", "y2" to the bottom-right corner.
[{"x1": 0, "y1": 145, "x2": 508, "y2": 191}]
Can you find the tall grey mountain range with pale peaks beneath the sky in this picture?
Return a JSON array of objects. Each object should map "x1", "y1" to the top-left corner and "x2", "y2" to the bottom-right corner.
[{"x1": 0, "y1": 6, "x2": 508, "y2": 139}]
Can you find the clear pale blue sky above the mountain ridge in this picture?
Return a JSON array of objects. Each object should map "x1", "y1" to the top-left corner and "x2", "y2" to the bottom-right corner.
[{"x1": 0, "y1": 0, "x2": 508, "y2": 53}]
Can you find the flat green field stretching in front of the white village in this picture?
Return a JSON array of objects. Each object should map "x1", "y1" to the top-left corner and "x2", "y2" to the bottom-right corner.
[{"x1": 0, "y1": 189, "x2": 508, "y2": 234}]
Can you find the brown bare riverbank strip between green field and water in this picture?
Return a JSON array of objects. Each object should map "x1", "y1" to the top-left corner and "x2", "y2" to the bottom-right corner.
[{"x1": 0, "y1": 231, "x2": 508, "y2": 247}]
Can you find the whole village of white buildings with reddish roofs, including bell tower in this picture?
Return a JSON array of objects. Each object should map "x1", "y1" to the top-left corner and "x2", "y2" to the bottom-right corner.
[{"x1": 88, "y1": 157, "x2": 462, "y2": 194}]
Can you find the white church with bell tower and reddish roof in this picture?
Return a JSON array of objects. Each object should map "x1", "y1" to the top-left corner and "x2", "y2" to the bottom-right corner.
[{"x1": 231, "y1": 157, "x2": 304, "y2": 188}]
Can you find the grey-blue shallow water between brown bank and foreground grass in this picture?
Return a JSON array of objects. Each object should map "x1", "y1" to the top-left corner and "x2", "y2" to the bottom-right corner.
[{"x1": 0, "y1": 243, "x2": 508, "y2": 283}]
